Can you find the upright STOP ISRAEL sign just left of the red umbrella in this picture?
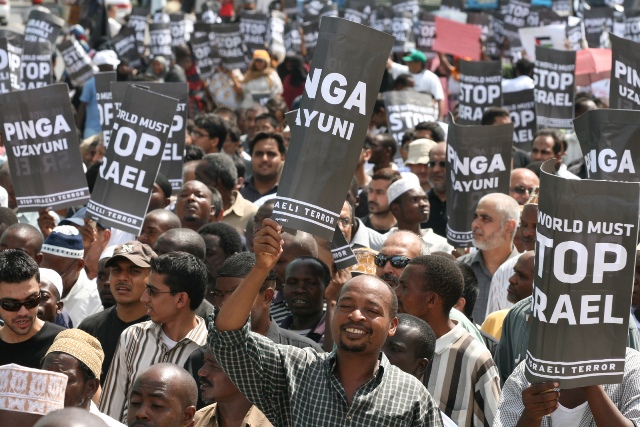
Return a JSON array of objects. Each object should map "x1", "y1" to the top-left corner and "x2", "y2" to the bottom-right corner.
[{"x1": 533, "y1": 46, "x2": 576, "y2": 129}]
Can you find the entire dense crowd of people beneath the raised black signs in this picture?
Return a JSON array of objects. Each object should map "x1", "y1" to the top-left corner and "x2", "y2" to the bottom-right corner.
[{"x1": 0, "y1": 0, "x2": 640, "y2": 427}]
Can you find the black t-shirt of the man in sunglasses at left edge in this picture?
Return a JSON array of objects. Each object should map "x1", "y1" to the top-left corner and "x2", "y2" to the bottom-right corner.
[{"x1": 0, "y1": 322, "x2": 65, "y2": 369}]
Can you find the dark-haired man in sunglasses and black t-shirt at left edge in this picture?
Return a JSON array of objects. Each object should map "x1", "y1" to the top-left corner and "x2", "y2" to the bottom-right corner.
[{"x1": 0, "y1": 249, "x2": 64, "y2": 369}]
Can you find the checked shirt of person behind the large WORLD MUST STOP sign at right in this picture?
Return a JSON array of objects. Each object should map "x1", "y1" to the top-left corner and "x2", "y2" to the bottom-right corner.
[{"x1": 493, "y1": 348, "x2": 640, "y2": 427}]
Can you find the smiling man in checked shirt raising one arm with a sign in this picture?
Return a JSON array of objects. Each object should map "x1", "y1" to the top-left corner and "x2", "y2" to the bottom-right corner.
[{"x1": 209, "y1": 219, "x2": 442, "y2": 427}]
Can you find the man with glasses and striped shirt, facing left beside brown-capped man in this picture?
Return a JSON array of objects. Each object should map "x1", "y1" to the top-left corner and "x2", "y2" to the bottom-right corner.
[{"x1": 100, "y1": 252, "x2": 207, "y2": 422}]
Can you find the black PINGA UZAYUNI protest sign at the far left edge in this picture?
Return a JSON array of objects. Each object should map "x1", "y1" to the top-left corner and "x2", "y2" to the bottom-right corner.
[{"x1": 0, "y1": 83, "x2": 89, "y2": 211}]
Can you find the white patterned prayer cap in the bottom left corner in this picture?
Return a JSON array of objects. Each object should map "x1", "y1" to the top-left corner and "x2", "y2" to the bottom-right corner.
[{"x1": 0, "y1": 363, "x2": 68, "y2": 415}]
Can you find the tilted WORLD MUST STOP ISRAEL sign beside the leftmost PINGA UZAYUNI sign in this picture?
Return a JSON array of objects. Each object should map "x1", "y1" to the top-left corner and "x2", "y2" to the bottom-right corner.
[{"x1": 87, "y1": 85, "x2": 178, "y2": 235}]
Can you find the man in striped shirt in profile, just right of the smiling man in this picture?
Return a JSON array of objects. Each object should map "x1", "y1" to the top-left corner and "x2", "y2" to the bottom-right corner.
[{"x1": 396, "y1": 256, "x2": 500, "y2": 427}]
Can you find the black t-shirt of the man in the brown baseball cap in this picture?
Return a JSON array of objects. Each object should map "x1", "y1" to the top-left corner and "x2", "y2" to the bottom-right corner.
[{"x1": 78, "y1": 306, "x2": 149, "y2": 385}]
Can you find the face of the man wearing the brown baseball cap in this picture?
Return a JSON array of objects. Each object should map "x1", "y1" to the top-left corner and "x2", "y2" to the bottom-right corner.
[{"x1": 109, "y1": 257, "x2": 150, "y2": 305}]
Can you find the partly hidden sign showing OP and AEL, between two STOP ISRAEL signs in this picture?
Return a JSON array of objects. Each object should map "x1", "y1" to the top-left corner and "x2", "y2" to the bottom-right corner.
[{"x1": 502, "y1": 89, "x2": 538, "y2": 151}]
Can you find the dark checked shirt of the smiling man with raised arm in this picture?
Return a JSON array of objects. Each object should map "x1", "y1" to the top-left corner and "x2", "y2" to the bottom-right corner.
[{"x1": 209, "y1": 321, "x2": 442, "y2": 427}]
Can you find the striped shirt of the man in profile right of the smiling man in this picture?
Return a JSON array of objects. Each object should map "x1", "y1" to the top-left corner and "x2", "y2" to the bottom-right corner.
[{"x1": 423, "y1": 324, "x2": 500, "y2": 427}]
